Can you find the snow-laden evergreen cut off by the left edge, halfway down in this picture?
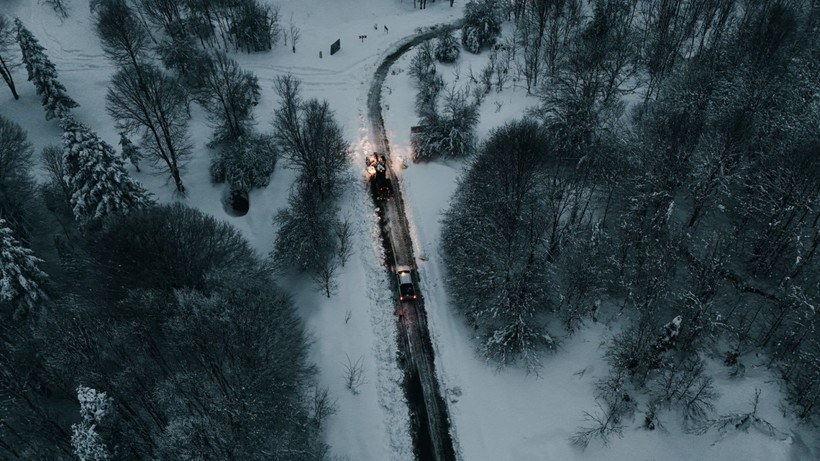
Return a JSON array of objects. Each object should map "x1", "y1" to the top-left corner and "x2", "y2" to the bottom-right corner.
[{"x1": 0, "y1": 219, "x2": 46, "y2": 320}]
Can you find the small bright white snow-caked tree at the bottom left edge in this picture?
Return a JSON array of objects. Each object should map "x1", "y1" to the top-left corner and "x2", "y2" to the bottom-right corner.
[{"x1": 71, "y1": 386, "x2": 112, "y2": 461}]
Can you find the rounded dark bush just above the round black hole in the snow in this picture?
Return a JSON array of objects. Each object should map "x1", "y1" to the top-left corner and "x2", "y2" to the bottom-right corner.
[{"x1": 211, "y1": 132, "x2": 278, "y2": 191}]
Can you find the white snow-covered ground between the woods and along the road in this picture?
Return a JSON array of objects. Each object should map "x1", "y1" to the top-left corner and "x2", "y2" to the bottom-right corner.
[{"x1": 0, "y1": 0, "x2": 816, "y2": 461}]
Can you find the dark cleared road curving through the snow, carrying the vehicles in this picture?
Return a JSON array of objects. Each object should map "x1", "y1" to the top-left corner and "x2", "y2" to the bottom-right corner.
[{"x1": 367, "y1": 21, "x2": 461, "y2": 461}]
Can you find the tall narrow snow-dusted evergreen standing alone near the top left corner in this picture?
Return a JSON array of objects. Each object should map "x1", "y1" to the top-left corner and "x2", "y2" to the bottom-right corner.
[{"x1": 14, "y1": 19, "x2": 78, "y2": 120}]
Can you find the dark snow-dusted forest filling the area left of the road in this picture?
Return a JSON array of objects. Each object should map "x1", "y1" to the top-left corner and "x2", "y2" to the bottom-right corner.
[{"x1": 0, "y1": 0, "x2": 342, "y2": 460}]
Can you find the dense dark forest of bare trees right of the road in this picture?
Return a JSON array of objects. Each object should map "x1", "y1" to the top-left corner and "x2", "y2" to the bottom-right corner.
[{"x1": 430, "y1": 0, "x2": 820, "y2": 440}]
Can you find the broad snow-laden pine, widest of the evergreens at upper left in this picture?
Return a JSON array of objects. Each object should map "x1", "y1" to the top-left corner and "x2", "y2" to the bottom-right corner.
[{"x1": 62, "y1": 117, "x2": 152, "y2": 225}]
